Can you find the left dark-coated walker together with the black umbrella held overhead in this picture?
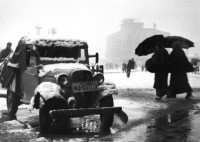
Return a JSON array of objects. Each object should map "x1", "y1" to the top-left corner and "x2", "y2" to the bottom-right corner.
[{"x1": 135, "y1": 35, "x2": 169, "y2": 100}]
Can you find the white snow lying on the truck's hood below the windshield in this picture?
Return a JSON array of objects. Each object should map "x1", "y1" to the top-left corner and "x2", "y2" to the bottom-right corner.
[{"x1": 39, "y1": 63, "x2": 88, "y2": 77}]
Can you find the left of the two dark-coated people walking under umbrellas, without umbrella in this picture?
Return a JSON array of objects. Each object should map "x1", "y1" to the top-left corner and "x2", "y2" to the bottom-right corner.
[{"x1": 152, "y1": 45, "x2": 169, "y2": 100}]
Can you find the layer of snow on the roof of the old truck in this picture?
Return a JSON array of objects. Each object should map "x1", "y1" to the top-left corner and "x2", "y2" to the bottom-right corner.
[{"x1": 21, "y1": 36, "x2": 88, "y2": 48}]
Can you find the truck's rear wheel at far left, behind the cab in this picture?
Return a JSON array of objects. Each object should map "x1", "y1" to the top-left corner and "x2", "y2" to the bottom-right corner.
[{"x1": 7, "y1": 89, "x2": 19, "y2": 116}]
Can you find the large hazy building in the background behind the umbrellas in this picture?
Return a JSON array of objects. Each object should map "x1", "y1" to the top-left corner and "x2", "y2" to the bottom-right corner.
[{"x1": 105, "y1": 19, "x2": 170, "y2": 64}]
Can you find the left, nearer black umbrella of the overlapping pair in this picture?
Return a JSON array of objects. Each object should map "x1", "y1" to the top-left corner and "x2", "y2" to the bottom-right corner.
[{"x1": 135, "y1": 35, "x2": 166, "y2": 56}]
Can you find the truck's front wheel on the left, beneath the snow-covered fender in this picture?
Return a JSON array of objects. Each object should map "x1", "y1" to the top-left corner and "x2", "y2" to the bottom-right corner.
[{"x1": 39, "y1": 104, "x2": 51, "y2": 134}]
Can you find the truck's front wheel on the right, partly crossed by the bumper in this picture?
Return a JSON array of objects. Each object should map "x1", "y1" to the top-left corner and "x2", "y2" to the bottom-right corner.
[{"x1": 99, "y1": 95, "x2": 114, "y2": 131}]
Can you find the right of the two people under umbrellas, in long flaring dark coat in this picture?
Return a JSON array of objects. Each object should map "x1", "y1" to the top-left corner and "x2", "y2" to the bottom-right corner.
[{"x1": 168, "y1": 41, "x2": 194, "y2": 99}]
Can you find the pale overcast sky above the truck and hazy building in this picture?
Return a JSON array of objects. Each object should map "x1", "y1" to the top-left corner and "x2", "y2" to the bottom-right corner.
[{"x1": 0, "y1": 0, "x2": 200, "y2": 56}]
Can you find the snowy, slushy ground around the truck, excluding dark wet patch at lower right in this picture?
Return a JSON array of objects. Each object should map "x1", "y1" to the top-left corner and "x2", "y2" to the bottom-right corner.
[{"x1": 0, "y1": 71, "x2": 200, "y2": 141}]
